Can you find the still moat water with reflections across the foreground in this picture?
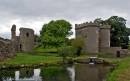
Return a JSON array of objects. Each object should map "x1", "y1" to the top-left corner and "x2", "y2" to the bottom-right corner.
[{"x1": 0, "y1": 64, "x2": 111, "y2": 81}]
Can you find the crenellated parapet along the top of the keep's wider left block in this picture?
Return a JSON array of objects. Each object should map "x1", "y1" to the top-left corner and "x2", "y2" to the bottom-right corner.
[{"x1": 75, "y1": 21, "x2": 100, "y2": 29}]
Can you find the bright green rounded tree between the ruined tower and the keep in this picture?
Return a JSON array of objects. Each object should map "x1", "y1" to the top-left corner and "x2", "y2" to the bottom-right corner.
[{"x1": 40, "y1": 20, "x2": 72, "y2": 47}]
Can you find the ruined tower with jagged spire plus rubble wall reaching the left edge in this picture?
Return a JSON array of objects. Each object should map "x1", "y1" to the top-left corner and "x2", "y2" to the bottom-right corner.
[{"x1": 0, "y1": 25, "x2": 35, "y2": 60}]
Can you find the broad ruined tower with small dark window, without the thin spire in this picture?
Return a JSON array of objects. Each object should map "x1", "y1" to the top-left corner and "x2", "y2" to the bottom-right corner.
[{"x1": 19, "y1": 28, "x2": 34, "y2": 52}]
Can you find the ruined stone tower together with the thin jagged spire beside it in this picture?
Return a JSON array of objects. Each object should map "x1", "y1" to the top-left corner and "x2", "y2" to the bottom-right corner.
[{"x1": 11, "y1": 25, "x2": 35, "y2": 52}]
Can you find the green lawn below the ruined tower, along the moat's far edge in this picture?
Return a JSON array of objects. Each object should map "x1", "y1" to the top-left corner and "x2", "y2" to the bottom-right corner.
[{"x1": 0, "y1": 53, "x2": 62, "y2": 65}]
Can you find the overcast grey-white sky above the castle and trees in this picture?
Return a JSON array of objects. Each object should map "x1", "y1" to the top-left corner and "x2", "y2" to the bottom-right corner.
[{"x1": 0, "y1": 0, "x2": 130, "y2": 38}]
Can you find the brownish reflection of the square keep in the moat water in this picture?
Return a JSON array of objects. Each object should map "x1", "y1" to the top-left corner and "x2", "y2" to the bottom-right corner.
[{"x1": 68, "y1": 64, "x2": 110, "y2": 81}]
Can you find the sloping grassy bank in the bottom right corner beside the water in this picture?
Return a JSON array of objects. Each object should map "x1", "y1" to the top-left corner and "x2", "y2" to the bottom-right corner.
[{"x1": 107, "y1": 57, "x2": 130, "y2": 81}]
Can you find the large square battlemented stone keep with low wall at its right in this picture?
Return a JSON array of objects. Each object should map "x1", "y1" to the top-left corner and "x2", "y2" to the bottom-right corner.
[{"x1": 75, "y1": 22, "x2": 127, "y2": 53}]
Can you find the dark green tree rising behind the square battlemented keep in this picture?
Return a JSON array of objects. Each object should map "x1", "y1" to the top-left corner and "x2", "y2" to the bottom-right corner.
[{"x1": 94, "y1": 16, "x2": 130, "y2": 48}]
